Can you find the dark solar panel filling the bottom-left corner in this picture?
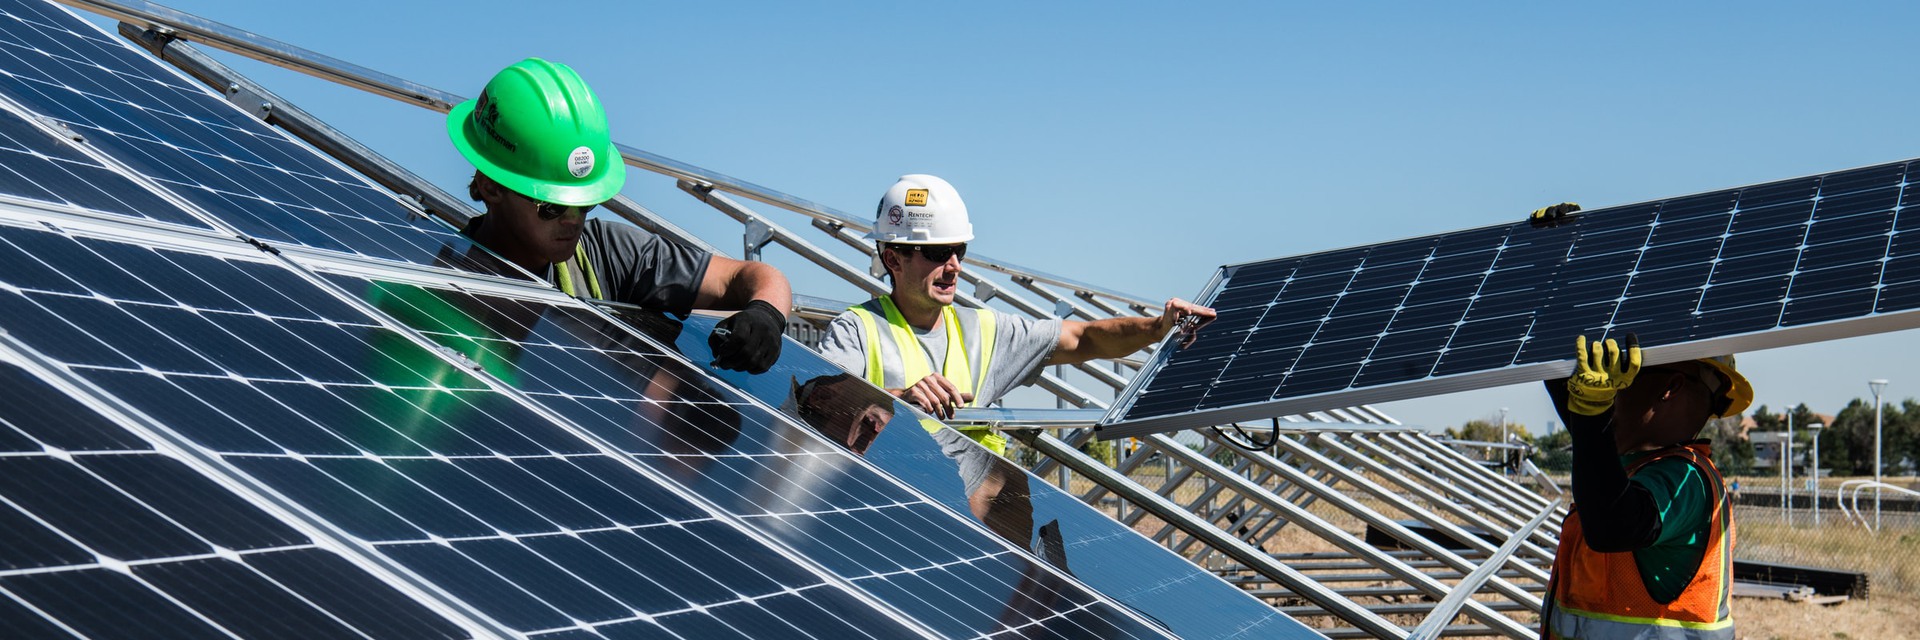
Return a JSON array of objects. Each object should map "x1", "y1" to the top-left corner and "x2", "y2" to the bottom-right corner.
[{"x1": 0, "y1": 355, "x2": 480, "y2": 638}]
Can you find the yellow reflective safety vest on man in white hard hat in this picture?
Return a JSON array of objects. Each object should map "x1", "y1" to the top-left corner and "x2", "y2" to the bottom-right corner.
[{"x1": 849, "y1": 296, "x2": 1006, "y2": 455}]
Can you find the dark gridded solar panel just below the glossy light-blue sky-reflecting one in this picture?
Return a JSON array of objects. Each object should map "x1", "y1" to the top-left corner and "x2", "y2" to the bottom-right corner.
[{"x1": 351, "y1": 275, "x2": 1175, "y2": 638}]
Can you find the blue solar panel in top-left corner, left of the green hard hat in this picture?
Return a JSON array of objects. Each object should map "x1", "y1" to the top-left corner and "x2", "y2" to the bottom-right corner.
[{"x1": 0, "y1": 0, "x2": 503, "y2": 263}]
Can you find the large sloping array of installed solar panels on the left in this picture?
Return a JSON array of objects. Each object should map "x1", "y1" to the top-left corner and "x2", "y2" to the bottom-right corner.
[{"x1": 0, "y1": 0, "x2": 1309, "y2": 638}]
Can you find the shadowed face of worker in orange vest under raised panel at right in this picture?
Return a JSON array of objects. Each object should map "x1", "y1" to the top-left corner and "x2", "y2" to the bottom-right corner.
[{"x1": 1613, "y1": 367, "x2": 1709, "y2": 454}]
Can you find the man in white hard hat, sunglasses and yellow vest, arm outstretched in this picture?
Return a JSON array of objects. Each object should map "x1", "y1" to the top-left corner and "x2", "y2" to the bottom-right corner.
[{"x1": 820, "y1": 173, "x2": 1213, "y2": 454}]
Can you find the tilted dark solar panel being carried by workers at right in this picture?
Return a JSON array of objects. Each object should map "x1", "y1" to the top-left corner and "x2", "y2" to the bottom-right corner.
[{"x1": 1102, "y1": 161, "x2": 1920, "y2": 438}]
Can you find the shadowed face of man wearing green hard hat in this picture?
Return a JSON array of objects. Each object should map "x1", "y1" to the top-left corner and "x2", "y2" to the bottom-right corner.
[{"x1": 482, "y1": 181, "x2": 593, "y2": 271}]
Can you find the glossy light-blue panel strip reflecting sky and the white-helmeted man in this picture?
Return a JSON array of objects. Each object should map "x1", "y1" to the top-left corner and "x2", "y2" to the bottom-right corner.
[{"x1": 674, "y1": 315, "x2": 1317, "y2": 638}]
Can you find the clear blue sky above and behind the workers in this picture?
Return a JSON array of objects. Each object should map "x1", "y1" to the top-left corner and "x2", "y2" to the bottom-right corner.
[{"x1": 86, "y1": 0, "x2": 1920, "y2": 432}]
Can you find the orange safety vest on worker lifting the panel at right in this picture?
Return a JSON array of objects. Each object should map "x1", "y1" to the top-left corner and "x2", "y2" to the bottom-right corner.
[{"x1": 1540, "y1": 442, "x2": 1734, "y2": 640}]
